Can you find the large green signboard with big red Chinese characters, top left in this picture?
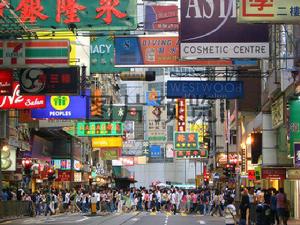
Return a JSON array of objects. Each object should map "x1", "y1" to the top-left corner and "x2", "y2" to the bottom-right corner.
[{"x1": 8, "y1": 0, "x2": 137, "y2": 31}]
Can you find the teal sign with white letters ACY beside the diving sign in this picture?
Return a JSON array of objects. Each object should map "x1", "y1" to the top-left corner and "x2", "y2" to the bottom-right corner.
[{"x1": 90, "y1": 36, "x2": 129, "y2": 73}]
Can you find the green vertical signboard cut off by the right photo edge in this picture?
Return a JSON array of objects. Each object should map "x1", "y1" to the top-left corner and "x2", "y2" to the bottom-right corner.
[{"x1": 289, "y1": 100, "x2": 300, "y2": 156}]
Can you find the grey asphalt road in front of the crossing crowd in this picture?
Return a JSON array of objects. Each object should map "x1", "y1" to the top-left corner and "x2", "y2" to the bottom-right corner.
[{"x1": 1, "y1": 212, "x2": 224, "y2": 225}]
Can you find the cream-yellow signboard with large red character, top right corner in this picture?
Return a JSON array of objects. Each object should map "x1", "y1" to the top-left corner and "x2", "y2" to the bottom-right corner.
[{"x1": 238, "y1": 0, "x2": 300, "y2": 23}]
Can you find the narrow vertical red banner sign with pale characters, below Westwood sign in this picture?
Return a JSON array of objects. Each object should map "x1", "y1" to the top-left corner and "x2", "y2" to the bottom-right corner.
[{"x1": 176, "y1": 98, "x2": 187, "y2": 132}]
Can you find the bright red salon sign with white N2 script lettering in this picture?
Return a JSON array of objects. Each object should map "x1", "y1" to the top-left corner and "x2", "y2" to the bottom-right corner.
[{"x1": 0, "y1": 82, "x2": 46, "y2": 109}]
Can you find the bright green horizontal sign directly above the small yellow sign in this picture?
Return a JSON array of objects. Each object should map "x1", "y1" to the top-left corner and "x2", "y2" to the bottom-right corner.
[{"x1": 77, "y1": 122, "x2": 124, "y2": 137}]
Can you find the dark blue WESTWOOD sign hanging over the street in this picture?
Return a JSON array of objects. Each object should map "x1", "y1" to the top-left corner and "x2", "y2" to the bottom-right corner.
[{"x1": 167, "y1": 81, "x2": 244, "y2": 99}]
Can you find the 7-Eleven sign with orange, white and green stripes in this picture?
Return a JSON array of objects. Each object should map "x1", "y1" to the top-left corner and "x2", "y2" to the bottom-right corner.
[{"x1": 0, "y1": 40, "x2": 70, "y2": 68}]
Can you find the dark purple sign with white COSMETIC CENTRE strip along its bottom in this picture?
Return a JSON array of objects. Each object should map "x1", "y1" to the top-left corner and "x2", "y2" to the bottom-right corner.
[{"x1": 180, "y1": 0, "x2": 269, "y2": 59}]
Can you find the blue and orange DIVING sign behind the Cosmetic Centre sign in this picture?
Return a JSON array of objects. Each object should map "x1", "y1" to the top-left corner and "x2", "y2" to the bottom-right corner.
[{"x1": 115, "y1": 36, "x2": 232, "y2": 67}]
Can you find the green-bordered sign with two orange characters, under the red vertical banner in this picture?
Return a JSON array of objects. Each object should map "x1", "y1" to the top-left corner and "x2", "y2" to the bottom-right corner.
[{"x1": 174, "y1": 132, "x2": 199, "y2": 150}]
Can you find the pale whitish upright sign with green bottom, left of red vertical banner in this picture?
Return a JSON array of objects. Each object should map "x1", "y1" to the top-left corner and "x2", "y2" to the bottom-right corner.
[{"x1": 147, "y1": 106, "x2": 167, "y2": 143}]
